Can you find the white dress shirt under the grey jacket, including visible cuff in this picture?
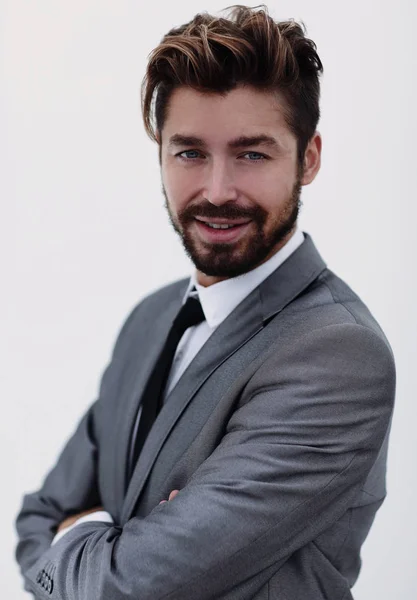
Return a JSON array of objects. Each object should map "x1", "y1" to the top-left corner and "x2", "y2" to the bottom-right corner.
[{"x1": 52, "y1": 229, "x2": 304, "y2": 544}]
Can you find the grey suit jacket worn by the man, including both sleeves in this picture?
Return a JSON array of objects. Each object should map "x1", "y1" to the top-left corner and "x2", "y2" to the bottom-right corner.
[{"x1": 16, "y1": 235, "x2": 395, "y2": 600}]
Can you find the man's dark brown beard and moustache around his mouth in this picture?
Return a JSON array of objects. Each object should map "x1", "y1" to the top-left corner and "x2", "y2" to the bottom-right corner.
[{"x1": 162, "y1": 169, "x2": 302, "y2": 278}]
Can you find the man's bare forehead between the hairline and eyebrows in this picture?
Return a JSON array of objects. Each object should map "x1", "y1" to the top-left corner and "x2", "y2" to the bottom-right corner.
[{"x1": 162, "y1": 86, "x2": 293, "y2": 142}]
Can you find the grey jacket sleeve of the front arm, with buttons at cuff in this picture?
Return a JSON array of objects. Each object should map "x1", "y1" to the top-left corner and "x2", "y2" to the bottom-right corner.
[{"x1": 22, "y1": 324, "x2": 395, "y2": 600}]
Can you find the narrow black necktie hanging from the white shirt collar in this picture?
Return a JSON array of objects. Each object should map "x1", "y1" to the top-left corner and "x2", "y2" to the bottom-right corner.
[{"x1": 131, "y1": 296, "x2": 205, "y2": 472}]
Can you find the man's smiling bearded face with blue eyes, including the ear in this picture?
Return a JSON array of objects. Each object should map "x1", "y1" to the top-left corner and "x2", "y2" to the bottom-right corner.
[{"x1": 160, "y1": 86, "x2": 321, "y2": 285}]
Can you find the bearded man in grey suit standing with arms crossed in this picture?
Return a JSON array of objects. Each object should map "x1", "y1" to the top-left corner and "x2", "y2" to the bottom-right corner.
[{"x1": 17, "y1": 7, "x2": 395, "y2": 600}]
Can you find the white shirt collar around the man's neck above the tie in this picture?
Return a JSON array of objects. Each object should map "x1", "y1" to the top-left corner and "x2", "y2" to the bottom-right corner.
[{"x1": 183, "y1": 229, "x2": 304, "y2": 328}]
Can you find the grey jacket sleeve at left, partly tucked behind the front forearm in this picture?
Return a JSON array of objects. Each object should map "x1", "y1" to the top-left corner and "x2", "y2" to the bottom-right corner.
[{"x1": 16, "y1": 306, "x2": 142, "y2": 587}]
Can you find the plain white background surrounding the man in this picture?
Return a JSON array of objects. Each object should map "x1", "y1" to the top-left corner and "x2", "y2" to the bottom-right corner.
[{"x1": 0, "y1": 0, "x2": 417, "y2": 600}]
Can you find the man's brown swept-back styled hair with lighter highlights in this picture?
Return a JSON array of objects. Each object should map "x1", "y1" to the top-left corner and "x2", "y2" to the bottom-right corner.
[{"x1": 141, "y1": 4, "x2": 323, "y2": 165}]
